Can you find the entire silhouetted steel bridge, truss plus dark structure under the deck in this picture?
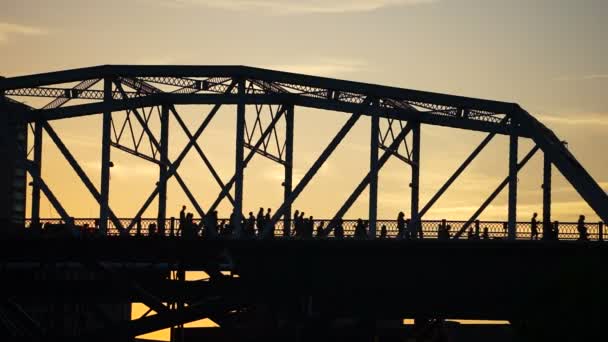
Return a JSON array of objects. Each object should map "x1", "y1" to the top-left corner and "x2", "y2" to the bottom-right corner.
[{"x1": 0, "y1": 65, "x2": 608, "y2": 341}]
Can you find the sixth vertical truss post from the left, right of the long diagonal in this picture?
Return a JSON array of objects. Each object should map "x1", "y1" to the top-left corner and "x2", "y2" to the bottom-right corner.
[{"x1": 369, "y1": 107, "x2": 380, "y2": 239}]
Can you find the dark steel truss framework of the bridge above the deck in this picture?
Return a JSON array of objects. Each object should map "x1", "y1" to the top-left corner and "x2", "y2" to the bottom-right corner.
[{"x1": 0, "y1": 65, "x2": 608, "y2": 238}]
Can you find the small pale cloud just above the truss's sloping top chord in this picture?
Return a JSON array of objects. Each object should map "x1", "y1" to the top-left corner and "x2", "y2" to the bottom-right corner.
[{"x1": 262, "y1": 58, "x2": 365, "y2": 76}]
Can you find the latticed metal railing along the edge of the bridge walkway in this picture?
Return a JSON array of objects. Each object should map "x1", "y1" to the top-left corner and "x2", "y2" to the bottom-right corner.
[{"x1": 25, "y1": 218, "x2": 604, "y2": 241}]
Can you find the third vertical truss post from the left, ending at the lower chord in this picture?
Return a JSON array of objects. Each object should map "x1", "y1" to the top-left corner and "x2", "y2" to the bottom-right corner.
[{"x1": 157, "y1": 105, "x2": 169, "y2": 235}]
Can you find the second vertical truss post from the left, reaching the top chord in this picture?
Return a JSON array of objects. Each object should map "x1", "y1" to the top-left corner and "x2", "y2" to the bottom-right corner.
[{"x1": 99, "y1": 78, "x2": 112, "y2": 235}]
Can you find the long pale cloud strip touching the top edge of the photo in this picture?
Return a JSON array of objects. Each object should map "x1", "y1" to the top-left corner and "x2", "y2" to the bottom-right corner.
[{"x1": 163, "y1": 0, "x2": 438, "y2": 14}]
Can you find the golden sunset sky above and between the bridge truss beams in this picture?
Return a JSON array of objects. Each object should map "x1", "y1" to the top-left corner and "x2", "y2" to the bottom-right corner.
[{"x1": 0, "y1": 0, "x2": 608, "y2": 221}]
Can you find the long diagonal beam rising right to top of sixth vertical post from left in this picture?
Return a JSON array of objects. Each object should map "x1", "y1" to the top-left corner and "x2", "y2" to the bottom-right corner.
[{"x1": 263, "y1": 98, "x2": 372, "y2": 238}]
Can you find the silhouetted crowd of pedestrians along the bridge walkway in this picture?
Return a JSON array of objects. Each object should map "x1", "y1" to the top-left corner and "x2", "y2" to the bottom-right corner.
[{"x1": 25, "y1": 206, "x2": 590, "y2": 241}]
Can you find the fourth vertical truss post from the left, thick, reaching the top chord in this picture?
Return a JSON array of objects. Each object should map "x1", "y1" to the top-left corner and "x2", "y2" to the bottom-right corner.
[{"x1": 234, "y1": 79, "x2": 246, "y2": 236}]
